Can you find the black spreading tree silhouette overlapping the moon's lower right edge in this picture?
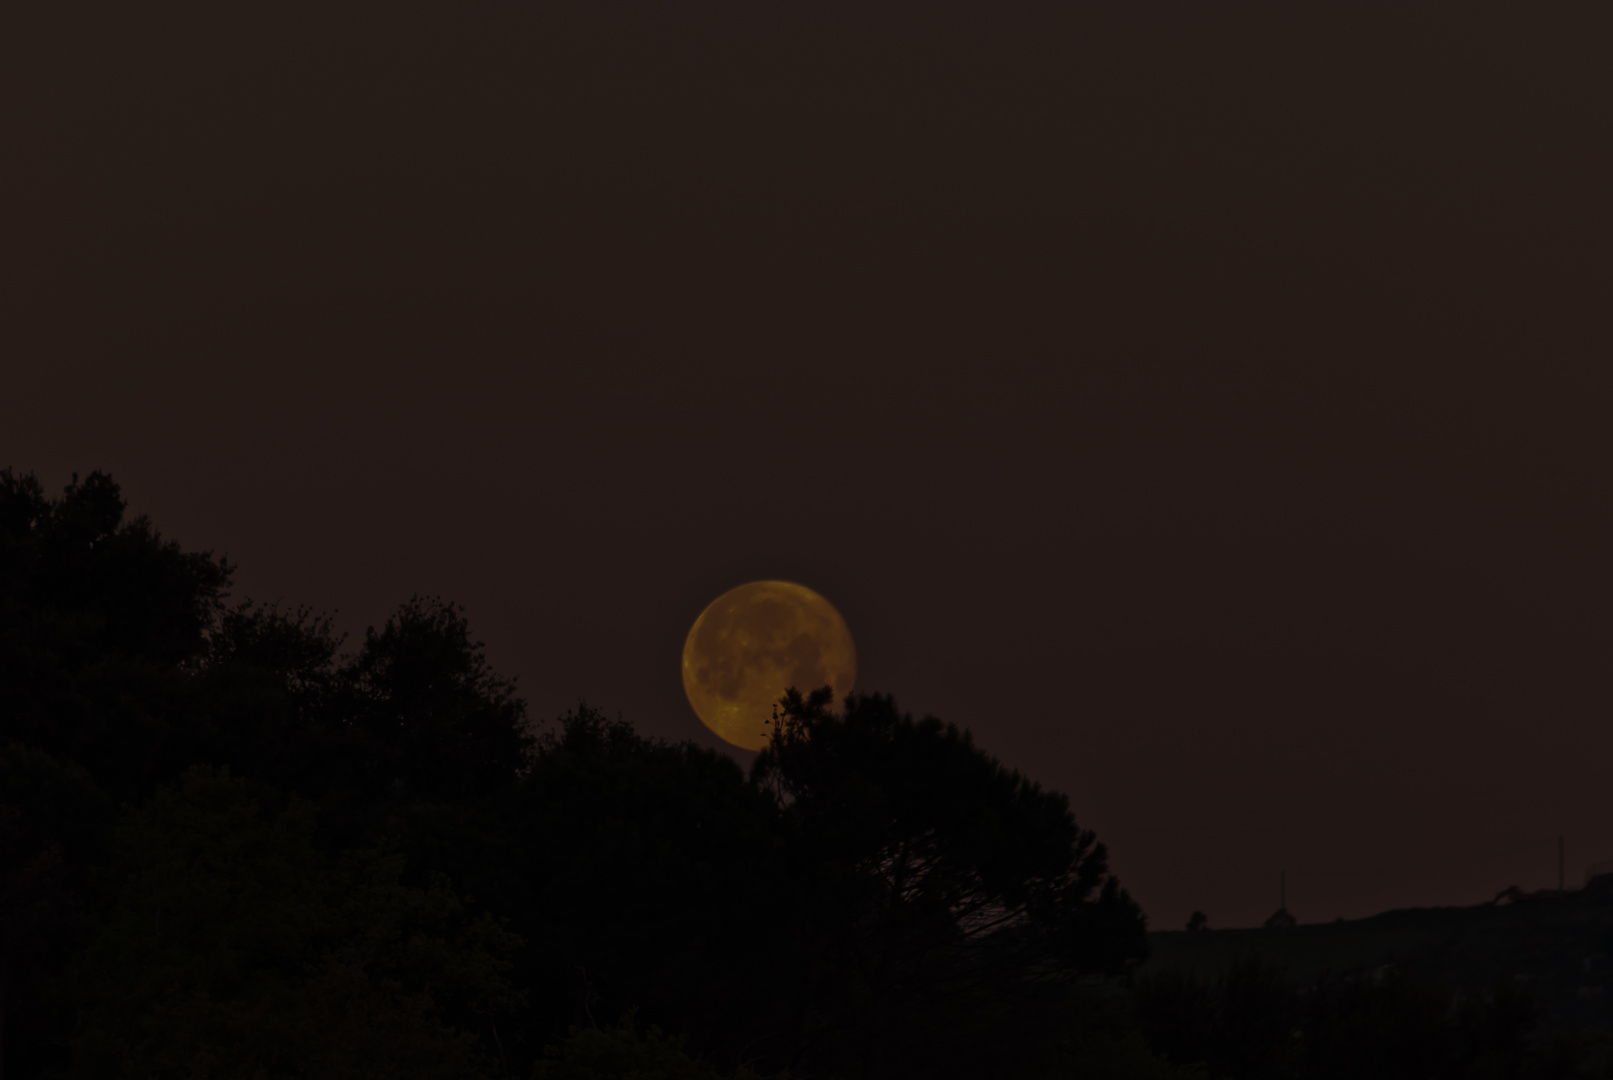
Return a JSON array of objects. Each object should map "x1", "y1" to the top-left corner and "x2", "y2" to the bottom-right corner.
[{"x1": 753, "y1": 688, "x2": 1145, "y2": 1077}]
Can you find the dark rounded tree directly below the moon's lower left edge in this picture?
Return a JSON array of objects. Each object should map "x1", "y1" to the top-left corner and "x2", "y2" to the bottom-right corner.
[{"x1": 503, "y1": 704, "x2": 792, "y2": 1067}]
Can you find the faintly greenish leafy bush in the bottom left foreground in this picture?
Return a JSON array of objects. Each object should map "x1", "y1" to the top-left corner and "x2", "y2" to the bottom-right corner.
[{"x1": 66, "y1": 767, "x2": 519, "y2": 1077}]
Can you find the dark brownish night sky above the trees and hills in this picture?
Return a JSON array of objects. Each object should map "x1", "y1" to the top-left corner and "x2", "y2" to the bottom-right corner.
[{"x1": 9, "y1": 0, "x2": 1613, "y2": 927}]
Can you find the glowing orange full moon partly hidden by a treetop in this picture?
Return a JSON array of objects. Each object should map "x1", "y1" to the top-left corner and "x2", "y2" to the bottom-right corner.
[{"x1": 684, "y1": 582, "x2": 857, "y2": 750}]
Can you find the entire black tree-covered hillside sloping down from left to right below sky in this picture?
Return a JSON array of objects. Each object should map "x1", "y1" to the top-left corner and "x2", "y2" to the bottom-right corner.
[{"x1": 0, "y1": 471, "x2": 1608, "y2": 1080}]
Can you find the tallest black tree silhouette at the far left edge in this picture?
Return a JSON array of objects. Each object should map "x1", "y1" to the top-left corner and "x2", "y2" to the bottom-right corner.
[{"x1": 0, "y1": 469, "x2": 231, "y2": 798}]
